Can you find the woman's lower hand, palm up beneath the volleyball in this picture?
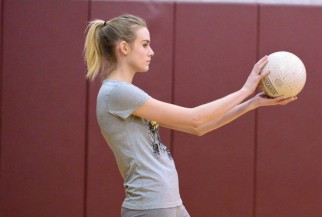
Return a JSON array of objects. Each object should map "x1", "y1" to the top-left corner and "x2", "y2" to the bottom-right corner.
[{"x1": 252, "y1": 92, "x2": 297, "y2": 108}]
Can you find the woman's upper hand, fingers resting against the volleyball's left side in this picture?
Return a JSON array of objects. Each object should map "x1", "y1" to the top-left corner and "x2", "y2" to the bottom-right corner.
[{"x1": 242, "y1": 56, "x2": 269, "y2": 95}]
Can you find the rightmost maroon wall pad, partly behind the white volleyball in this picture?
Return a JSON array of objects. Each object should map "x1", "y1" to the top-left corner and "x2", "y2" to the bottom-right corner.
[{"x1": 256, "y1": 5, "x2": 322, "y2": 217}]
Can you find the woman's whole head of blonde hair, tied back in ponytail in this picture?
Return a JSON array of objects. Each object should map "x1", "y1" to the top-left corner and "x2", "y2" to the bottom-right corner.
[{"x1": 84, "y1": 14, "x2": 147, "y2": 80}]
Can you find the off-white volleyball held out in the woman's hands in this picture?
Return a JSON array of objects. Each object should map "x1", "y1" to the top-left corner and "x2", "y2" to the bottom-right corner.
[{"x1": 259, "y1": 51, "x2": 306, "y2": 98}]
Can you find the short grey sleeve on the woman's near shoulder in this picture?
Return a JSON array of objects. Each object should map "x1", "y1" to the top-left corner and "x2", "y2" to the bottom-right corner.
[{"x1": 108, "y1": 83, "x2": 151, "y2": 119}]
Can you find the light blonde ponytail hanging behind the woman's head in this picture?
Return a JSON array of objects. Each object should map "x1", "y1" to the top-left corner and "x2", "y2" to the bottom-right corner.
[{"x1": 84, "y1": 20, "x2": 105, "y2": 80}]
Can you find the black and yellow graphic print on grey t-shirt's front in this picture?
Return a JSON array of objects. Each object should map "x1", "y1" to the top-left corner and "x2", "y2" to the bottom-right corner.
[{"x1": 145, "y1": 120, "x2": 172, "y2": 160}]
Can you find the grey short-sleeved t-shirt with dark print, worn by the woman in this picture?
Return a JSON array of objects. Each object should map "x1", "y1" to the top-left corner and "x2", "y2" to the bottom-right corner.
[{"x1": 96, "y1": 79, "x2": 182, "y2": 210}]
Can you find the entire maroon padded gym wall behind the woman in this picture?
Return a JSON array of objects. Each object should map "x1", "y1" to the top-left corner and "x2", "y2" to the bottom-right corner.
[{"x1": 0, "y1": 0, "x2": 322, "y2": 217}]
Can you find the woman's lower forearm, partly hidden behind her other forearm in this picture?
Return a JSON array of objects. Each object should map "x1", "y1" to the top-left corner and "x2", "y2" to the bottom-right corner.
[{"x1": 196, "y1": 99, "x2": 256, "y2": 135}]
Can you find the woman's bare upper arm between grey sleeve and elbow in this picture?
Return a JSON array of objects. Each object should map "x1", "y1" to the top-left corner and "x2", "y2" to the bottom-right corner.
[{"x1": 133, "y1": 98, "x2": 197, "y2": 132}]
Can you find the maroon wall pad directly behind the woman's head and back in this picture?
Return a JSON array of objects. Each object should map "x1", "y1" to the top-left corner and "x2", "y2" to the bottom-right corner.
[{"x1": 87, "y1": 2, "x2": 173, "y2": 217}]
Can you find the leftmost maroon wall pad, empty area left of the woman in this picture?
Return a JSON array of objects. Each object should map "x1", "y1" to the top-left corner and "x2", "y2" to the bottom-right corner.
[{"x1": 0, "y1": 0, "x2": 87, "y2": 217}]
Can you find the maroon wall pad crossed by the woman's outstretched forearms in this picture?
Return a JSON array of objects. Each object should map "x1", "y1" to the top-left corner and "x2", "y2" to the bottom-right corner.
[{"x1": 173, "y1": 3, "x2": 257, "y2": 217}]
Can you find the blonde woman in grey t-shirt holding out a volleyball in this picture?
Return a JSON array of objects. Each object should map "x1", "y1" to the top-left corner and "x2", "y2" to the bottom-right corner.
[{"x1": 84, "y1": 15, "x2": 296, "y2": 217}]
